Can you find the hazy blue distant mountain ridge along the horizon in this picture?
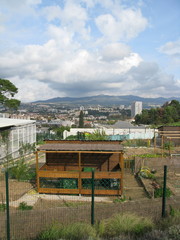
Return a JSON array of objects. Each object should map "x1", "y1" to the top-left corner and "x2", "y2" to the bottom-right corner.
[{"x1": 34, "y1": 95, "x2": 180, "y2": 107}]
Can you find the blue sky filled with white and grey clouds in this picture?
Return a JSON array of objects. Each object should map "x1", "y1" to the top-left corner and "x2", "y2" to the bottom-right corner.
[{"x1": 0, "y1": 0, "x2": 180, "y2": 102}]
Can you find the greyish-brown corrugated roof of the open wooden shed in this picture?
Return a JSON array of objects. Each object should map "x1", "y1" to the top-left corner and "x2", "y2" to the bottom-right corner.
[{"x1": 38, "y1": 143, "x2": 123, "y2": 152}]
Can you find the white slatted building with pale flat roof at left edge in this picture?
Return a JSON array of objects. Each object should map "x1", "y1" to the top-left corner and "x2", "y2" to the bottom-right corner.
[{"x1": 0, "y1": 118, "x2": 36, "y2": 163}]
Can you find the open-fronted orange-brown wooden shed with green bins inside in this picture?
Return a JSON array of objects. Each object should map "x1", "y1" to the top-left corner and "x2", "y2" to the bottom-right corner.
[{"x1": 36, "y1": 140, "x2": 124, "y2": 195}]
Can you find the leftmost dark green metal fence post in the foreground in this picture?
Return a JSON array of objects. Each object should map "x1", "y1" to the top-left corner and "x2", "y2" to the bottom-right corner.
[{"x1": 5, "y1": 170, "x2": 10, "y2": 240}]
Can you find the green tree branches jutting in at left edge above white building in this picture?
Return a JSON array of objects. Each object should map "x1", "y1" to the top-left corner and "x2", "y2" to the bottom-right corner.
[{"x1": 0, "y1": 78, "x2": 20, "y2": 109}]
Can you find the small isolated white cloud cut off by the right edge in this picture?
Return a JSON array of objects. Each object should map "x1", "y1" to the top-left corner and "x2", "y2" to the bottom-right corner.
[{"x1": 159, "y1": 40, "x2": 180, "y2": 57}]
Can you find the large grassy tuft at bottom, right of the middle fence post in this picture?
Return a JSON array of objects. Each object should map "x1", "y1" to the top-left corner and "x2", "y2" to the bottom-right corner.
[{"x1": 103, "y1": 214, "x2": 153, "y2": 237}]
